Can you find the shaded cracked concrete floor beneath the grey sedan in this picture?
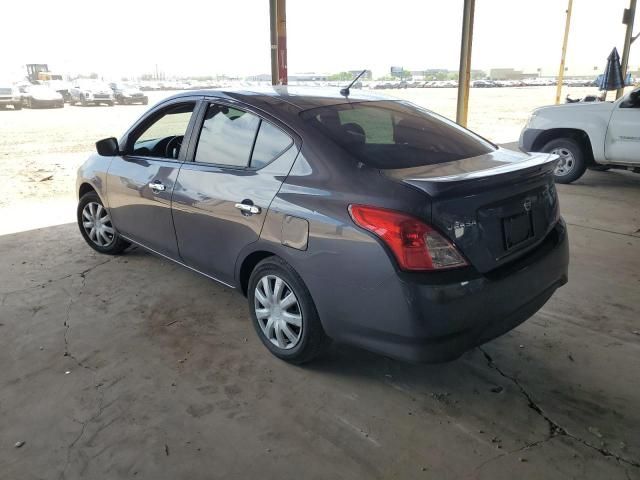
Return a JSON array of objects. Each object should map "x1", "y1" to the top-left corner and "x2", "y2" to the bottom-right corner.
[{"x1": 0, "y1": 171, "x2": 640, "y2": 480}]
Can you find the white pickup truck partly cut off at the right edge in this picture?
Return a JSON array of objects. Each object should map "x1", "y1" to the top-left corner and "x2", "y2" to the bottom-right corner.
[{"x1": 520, "y1": 88, "x2": 640, "y2": 183}]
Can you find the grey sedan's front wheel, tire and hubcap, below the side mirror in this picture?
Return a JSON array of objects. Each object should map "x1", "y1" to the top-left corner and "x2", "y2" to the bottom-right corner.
[{"x1": 77, "y1": 192, "x2": 130, "y2": 255}]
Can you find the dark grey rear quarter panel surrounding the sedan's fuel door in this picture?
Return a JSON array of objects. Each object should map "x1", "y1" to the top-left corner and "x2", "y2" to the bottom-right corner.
[{"x1": 244, "y1": 138, "x2": 430, "y2": 340}]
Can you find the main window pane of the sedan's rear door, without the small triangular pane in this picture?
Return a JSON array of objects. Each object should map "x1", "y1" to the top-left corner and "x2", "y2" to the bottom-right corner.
[{"x1": 195, "y1": 104, "x2": 260, "y2": 167}]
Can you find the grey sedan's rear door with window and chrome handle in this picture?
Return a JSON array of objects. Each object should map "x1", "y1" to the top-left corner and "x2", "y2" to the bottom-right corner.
[{"x1": 173, "y1": 101, "x2": 298, "y2": 284}]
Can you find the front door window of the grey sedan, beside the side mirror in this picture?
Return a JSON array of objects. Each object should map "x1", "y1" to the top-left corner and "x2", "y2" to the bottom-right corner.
[{"x1": 129, "y1": 102, "x2": 195, "y2": 159}]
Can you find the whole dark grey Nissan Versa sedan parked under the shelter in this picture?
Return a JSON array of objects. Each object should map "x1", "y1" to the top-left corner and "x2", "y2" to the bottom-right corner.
[{"x1": 77, "y1": 87, "x2": 569, "y2": 363}]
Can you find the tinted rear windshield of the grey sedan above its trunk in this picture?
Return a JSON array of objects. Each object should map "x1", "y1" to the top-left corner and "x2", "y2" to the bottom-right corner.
[{"x1": 301, "y1": 101, "x2": 496, "y2": 169}]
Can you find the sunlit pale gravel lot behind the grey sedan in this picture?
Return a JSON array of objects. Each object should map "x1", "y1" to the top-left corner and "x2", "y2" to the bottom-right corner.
[{"x1": 0, "y1": 87, "x2": 613, "y2": 209}]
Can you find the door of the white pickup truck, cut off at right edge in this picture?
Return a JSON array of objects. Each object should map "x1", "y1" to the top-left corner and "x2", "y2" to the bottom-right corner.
[{"x1": 605, "y1": 90, "x2": 640, "y2": 164}]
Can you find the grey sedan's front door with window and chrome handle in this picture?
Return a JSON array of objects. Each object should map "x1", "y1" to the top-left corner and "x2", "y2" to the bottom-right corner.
[{"x1": 107, "y1": 100, "x2": 197, "y2": 259}]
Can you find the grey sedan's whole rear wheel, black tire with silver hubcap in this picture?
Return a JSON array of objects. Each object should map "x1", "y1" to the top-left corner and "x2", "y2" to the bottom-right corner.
[{"x1": 247, "y1": 257, "x2": 330, "y2": 364}]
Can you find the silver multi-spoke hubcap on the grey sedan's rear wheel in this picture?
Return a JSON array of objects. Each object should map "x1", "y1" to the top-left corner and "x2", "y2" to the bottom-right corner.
[{"x1": 254, "y1": 275, "x2": 302, "y2": 350}]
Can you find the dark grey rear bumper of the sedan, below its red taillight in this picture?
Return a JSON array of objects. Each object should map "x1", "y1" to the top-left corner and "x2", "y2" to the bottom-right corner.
[{"x1": 323, "y1": 220, "x2": 569, "y2": 363}]
